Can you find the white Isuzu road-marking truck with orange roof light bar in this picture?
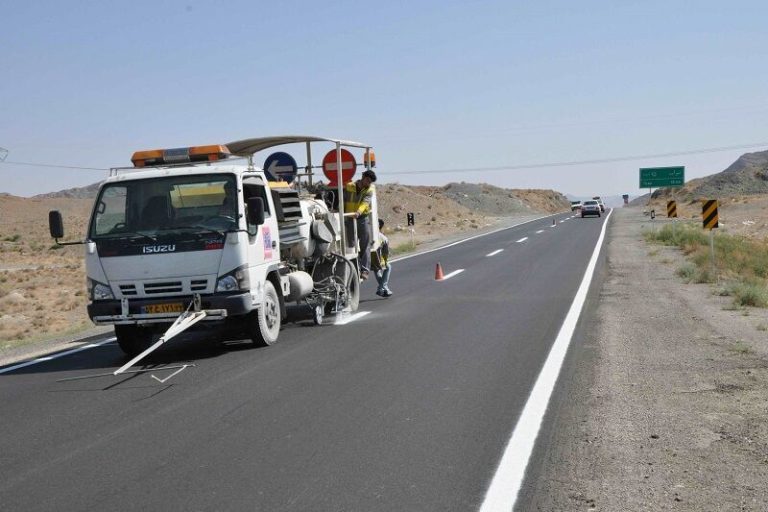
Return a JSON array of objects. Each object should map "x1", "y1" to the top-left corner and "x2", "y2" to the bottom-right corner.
[{"x1": 49, "y1": 136, "x2": 378, "y2": 356}]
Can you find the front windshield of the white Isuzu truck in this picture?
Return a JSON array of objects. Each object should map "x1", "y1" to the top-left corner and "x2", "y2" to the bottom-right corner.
[{"x1": 89, "y1": 174, "x2": 238, "y2": 240}]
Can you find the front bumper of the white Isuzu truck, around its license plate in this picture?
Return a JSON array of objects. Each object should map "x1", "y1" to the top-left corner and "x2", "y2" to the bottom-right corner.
[{"x1": 88, "y1": 292, "x2": 255, "y2": 325}]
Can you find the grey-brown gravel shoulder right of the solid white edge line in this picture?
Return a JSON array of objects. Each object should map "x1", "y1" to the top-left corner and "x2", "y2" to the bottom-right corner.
[{"x1": 519, "y1": 208, "x2": 768, "y2": 511}]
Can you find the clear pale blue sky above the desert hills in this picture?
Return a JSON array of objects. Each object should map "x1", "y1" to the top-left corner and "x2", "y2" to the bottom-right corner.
[{"x1": 0, "y1": 0, "x2": 768, "y2": 196}]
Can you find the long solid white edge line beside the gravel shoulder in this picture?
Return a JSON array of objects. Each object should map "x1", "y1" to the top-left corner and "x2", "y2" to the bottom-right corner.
[{"x1": 480, "y1": 213, "x2": 610, "y2": 512}]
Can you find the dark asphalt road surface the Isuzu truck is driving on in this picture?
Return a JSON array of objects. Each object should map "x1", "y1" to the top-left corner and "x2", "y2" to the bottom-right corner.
[{"x1": 0, "y1": 210, "x2": 605, "y2": 511}]
